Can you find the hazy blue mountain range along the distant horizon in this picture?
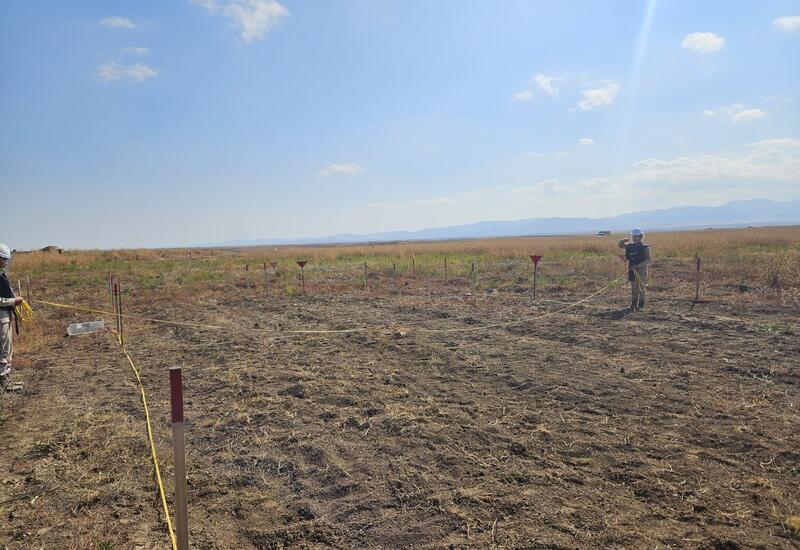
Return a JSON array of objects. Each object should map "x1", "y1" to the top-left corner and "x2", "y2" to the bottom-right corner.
[{"x1": 204, "y1": 199, "x2": 800, "y2": 247}]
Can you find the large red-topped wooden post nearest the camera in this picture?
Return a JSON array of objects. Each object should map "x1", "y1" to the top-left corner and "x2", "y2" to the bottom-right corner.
[{"x1": 169, "y1": 367, "x2": 189, "y2": 550}]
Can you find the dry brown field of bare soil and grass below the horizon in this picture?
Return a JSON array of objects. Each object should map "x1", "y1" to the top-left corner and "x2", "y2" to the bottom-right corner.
[{"x1": 0, "y1": 227, "x2": 800, "y2": 550}]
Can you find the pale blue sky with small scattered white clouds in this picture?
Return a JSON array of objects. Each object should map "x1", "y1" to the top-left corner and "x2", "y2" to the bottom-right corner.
[{"x1": 0, "y1": 0, "x2": 800, "y2": 249}]
